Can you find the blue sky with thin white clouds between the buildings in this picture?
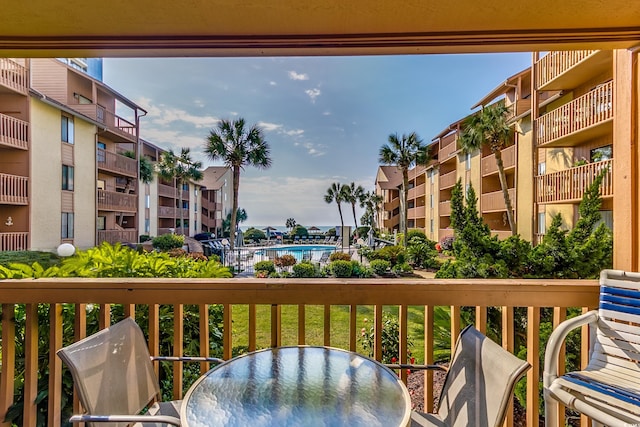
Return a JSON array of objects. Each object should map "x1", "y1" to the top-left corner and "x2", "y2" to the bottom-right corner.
[{"x1": 104, "y1": 53, "x2": 531, "y2": 227}]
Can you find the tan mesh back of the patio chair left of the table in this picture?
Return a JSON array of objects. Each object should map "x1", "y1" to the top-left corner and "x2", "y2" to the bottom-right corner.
[{"x1": 57, "y1": 318, "x2": 160, "y2": 427}]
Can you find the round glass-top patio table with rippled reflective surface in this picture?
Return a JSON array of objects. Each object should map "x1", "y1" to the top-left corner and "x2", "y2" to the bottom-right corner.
[{"x1": 181, "y1": 346, "x2": 411, "y2": 427}]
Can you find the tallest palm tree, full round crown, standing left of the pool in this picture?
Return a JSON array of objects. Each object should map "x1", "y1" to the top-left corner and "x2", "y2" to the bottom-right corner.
[{"x1": 204, "y1": 118, "x2": 271, "y2": 251}]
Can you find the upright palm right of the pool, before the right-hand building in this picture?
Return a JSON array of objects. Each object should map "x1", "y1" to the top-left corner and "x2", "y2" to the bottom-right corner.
[{"x1": 379, "y1": 132, "x2": 431, "y2": 246}]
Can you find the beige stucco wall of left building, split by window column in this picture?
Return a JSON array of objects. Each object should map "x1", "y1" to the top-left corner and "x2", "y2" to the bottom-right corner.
[{"x1": 31, "y1": 98, "x2": 96, "y2": 250}]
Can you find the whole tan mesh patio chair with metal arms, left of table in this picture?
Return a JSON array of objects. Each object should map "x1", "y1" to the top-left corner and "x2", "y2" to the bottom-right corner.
[{"x1": 57, "y1": 317, "x2": 222, "y2": 427}]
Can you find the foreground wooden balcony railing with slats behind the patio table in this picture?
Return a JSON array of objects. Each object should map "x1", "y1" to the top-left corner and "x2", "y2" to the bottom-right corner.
[{"x1": 0, "y1": 278, "x2": 599, "y2": 427}]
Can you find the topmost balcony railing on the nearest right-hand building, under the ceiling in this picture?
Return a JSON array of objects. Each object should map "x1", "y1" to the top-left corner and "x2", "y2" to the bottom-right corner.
[{"x1": 535, "y1": 50, "x2": 601, "y2": 90}]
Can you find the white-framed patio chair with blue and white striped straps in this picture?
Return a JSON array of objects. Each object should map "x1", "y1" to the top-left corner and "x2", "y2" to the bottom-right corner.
[{"x1": 543, "y1": 270, "x2": 640, "y2": 426}]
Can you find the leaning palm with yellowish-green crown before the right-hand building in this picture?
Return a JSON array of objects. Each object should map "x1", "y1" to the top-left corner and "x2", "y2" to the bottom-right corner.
[{"x1": 460, "y1": 103, "x2": 517, "y2": 235}]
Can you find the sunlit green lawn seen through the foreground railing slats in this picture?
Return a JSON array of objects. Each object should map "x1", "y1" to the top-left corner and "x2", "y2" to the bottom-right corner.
[{"x1": 232, "y1": 305, "x2": 448, "y2": 363}]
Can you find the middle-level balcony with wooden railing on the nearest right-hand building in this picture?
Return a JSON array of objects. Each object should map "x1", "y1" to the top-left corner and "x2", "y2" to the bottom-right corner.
[{"x1": 536, "y1": 81, "x2": 613, "y2": 147}]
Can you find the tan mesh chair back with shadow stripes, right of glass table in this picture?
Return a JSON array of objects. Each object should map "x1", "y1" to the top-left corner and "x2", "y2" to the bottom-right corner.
[{"x1": 438, "y1": 326, "x2": 530, "y2": 427}]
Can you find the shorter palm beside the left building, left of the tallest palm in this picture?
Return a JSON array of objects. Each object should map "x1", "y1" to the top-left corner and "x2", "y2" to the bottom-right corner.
[{"x1": 156, "y1": 148, "x2": 203, "y2": 235}]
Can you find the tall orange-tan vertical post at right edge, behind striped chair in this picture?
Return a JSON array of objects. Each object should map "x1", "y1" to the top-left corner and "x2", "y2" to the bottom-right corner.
[{"x1": 613, "y1": 50, "x2": 640, "y2": 271}]
